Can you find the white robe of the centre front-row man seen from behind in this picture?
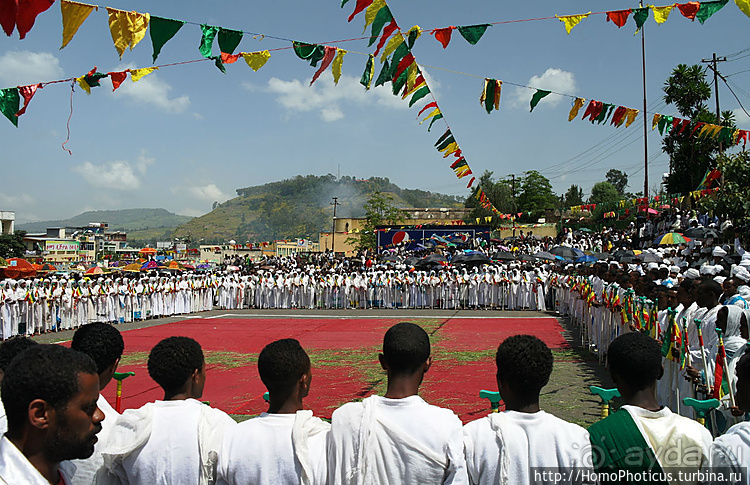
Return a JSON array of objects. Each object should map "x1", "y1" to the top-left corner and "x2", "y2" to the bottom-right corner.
[{"x1": 328, "y1": 396, "x2": 468, "y2": 485}]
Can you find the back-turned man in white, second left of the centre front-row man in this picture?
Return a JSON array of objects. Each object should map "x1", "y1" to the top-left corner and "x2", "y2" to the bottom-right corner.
[{"x1": 96, "y1": 337, "x2": 235, "y2": 485}]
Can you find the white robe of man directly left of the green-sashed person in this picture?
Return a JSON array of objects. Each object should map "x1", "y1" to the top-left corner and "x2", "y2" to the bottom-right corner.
[{"x1": 464, "y1": 411, "x2": 593, "y2": 485}]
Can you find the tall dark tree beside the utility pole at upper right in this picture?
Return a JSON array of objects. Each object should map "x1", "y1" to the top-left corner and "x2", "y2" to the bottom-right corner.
[{"x1": 662, "y1": 64, "x2": 735, "y2": 194}]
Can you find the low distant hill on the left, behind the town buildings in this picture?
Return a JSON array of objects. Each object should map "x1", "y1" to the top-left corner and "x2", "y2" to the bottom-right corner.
[{"x1": 16, "y1": 209, "x2": 192, "y2": 239}]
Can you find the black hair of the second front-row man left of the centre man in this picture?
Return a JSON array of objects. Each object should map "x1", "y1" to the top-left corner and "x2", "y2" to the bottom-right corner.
[{"x1": 148, "y1": 337, "x2": 204, "y2": 392}]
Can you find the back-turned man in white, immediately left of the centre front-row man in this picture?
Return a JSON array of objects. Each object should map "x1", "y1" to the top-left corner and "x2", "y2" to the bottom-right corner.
[{"x1": 217, "y1": 338, "x2": 331, "y2": 485}]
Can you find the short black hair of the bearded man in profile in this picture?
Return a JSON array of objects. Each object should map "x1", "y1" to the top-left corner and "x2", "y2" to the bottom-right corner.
[{"x1": 1, "y1": 345, "x2": 97, "y2": 436}]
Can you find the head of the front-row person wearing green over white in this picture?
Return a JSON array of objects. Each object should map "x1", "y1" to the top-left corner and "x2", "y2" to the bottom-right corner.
[{"x1": 607, "y1": 332, "x2": 664, "y2": 399}]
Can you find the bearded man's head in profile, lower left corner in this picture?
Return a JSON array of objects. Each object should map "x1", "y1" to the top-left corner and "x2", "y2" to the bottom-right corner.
[{"x1": 2, "y1": 345, "x2": 104, "y2": 463}]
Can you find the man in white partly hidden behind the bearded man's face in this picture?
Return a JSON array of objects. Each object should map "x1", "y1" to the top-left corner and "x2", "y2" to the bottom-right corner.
[{"x1": 70, "y1": 322, "x2": 125, "y2": 485}]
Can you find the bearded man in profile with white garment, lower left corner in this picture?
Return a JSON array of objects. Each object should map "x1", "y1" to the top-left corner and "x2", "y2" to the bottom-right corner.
[{"x1": 0, "y1": 345, "x2": 104, "y2": 485}]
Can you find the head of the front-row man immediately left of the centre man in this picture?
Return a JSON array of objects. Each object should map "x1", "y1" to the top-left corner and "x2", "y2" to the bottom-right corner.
[{"x1": 258, "y1": 338, "x2": 312, "y2": 400}]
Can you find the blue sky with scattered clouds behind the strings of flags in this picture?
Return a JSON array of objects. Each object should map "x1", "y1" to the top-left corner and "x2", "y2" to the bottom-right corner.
[{"x1": 0, "y1": 0, "x2": 750, "y2": 222}]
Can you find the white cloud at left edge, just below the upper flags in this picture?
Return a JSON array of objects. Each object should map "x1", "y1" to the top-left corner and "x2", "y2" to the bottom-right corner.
[{"x1": 0, "y1": 51, "x2": 63, "y2": 86}]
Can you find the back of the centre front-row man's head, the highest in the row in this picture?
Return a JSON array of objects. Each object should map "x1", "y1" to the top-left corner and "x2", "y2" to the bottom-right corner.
[{"x1": 380, "y1": 322, "x2": 432, "y2": 376}]
